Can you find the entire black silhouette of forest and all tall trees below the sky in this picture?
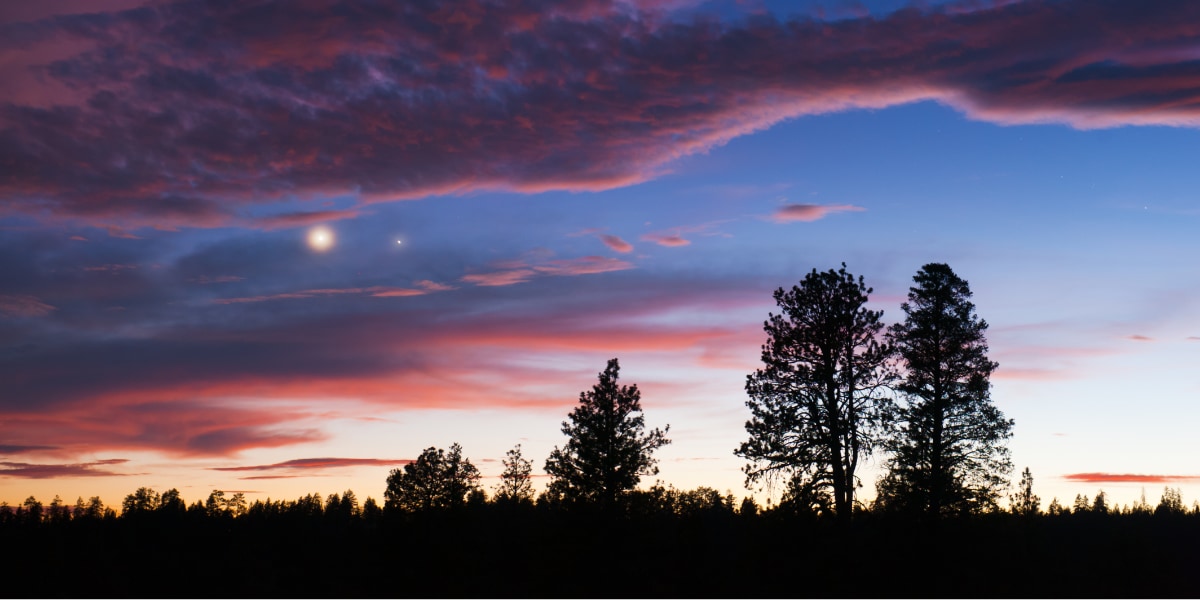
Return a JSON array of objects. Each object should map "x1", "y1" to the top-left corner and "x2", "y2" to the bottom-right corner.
[{"x1": 0, "y1": 263, "x2": 1200, "y2": 598}]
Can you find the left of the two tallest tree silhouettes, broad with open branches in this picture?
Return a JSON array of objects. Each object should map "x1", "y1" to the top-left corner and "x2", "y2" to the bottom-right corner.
[{"x1": 734, "y1": 264, "x2": 892, "y2": 521}]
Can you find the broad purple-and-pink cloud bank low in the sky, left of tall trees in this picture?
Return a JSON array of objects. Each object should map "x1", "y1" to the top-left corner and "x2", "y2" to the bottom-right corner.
[{"x1": 0, "y1": 274, "x2": 769, "y2": 456}]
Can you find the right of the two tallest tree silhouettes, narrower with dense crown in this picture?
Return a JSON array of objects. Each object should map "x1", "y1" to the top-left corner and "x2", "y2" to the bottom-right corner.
[{"x1": 878, "y1": 263, "x2": 1013, "y2": 518}]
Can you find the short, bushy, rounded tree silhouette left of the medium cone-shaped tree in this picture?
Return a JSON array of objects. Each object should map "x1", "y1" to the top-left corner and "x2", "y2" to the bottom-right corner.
[{"x1": 384, "y1": 444, "x2": 480, "y2": 512}]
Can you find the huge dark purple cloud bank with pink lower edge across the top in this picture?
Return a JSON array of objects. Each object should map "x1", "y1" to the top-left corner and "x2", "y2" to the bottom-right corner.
[{"x1": 0, "y1": 0, "x2": 1200, "y2": 229}]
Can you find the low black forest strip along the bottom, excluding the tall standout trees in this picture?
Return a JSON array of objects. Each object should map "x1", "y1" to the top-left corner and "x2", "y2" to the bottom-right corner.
[{"x1": 0, "y1": 485, "x2": 1200, "y2": 598}]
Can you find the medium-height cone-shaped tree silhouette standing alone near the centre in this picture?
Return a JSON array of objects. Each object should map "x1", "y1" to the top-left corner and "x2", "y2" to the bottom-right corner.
[{"x1": 546, "y1": 359, "x2": 671, "y2": 508}]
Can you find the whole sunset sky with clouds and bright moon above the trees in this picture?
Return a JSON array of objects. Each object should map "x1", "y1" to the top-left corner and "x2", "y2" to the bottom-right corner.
[{"x1": 0, "y1": 0, "x2": 1200, "y2": 505}]
